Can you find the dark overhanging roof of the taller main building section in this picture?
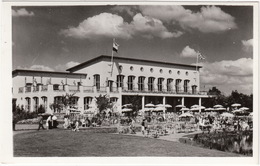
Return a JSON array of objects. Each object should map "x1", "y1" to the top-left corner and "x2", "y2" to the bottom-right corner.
[{"x1": 66, "y1": 55, "x2": 202, "y2": 72}]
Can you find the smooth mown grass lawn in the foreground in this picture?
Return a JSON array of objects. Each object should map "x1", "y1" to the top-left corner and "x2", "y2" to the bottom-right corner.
[{"x1": 14, "y1": 129, "x2": 242, "y2": 157}]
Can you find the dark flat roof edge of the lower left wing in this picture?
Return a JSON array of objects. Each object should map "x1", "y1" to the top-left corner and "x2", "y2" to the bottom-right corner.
[{"x1": 12, "y1": 69, "x2": 87, "y2": 77}]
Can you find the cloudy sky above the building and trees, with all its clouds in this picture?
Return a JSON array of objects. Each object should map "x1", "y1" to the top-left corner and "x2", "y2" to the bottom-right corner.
[{"x1": 12, "y1": 6, "x2": 253, "y2": 94}]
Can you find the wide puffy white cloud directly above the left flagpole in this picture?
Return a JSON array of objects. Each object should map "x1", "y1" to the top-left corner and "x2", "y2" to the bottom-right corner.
[{"x1": 60, "y1": 13, "x2": 183, "y2": 39}]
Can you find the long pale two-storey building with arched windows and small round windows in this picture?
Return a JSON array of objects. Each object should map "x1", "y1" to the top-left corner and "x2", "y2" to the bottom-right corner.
[{"x1": 12, "y1": 55, "x2": 213, "y2": 112}]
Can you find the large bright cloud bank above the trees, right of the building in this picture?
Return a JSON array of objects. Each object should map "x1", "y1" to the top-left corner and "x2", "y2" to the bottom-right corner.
[{"x1": 199, "y1": 58, "x2": 253, "y2": 94}]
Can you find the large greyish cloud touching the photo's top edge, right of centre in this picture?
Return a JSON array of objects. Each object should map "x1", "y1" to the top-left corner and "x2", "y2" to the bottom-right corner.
[{"x1": 140, "y1": 6, "x2": 237, "y2": 33}]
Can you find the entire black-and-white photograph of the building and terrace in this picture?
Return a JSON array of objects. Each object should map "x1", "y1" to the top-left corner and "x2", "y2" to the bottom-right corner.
[{"x1": 1, "y1": 2, "x2": 258, "y2": 164}]
